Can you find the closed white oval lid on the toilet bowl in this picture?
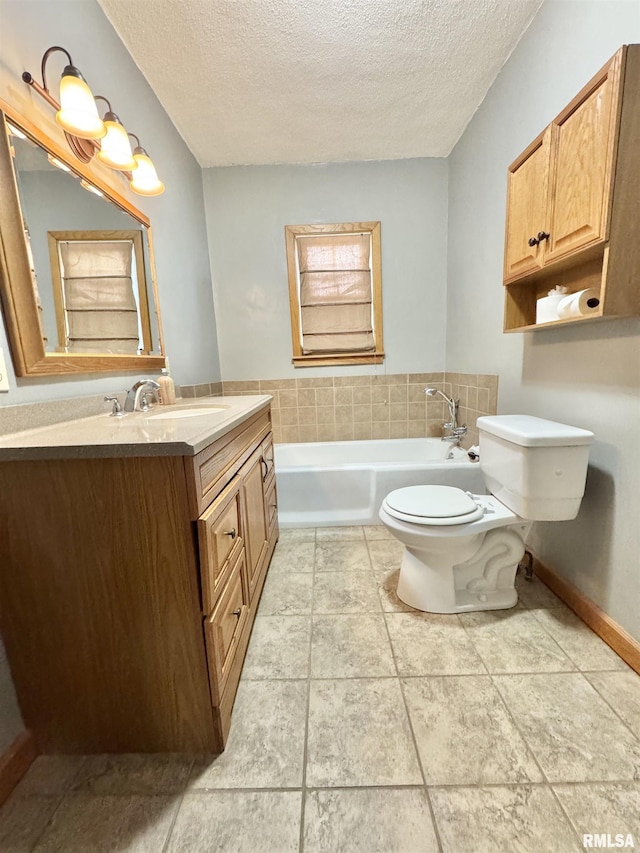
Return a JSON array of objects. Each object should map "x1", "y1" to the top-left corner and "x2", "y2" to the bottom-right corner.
[{"x1": 384, "y1": 486, "x2": 484, "y2": 525}]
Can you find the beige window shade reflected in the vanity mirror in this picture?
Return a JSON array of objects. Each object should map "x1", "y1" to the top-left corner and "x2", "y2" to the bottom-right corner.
[{"x1": 59, "y1": 240, "x2": 139, "y2": 353}]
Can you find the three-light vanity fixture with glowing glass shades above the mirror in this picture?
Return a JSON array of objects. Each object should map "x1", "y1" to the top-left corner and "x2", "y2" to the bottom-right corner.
[{"x1": 22, "y1": 45, "x2": 164, "y2": 196}]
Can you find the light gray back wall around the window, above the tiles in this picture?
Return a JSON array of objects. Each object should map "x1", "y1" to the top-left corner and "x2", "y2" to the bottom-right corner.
[{"x1": 204, "y1": 159, "x2": 447, "y2": 381}]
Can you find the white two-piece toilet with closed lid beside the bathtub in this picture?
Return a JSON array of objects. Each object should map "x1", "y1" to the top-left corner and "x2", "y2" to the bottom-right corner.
[{"x1": 379, "y1": 415, "x2": 594, "y2": 613}]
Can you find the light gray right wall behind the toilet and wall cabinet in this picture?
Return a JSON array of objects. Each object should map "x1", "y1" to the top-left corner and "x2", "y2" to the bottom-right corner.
[{"x1": 446, "y1": 0, "x2": 640, "y2": 639}]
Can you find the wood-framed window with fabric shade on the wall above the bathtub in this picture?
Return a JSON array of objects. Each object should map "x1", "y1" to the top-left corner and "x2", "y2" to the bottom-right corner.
[{"x1": 285, "y1": 222, "x2": 384, "y2": 367}]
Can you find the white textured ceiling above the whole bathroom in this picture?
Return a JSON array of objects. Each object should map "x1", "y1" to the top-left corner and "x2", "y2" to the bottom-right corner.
[{"x1": 99, "y1": 0, "x2": 542, "y2": 166}]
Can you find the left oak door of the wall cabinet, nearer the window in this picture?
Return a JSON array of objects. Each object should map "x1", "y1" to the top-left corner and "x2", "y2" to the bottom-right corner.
[{"x1": 504, "y1": 128, "x2": 551, "y2": 281}]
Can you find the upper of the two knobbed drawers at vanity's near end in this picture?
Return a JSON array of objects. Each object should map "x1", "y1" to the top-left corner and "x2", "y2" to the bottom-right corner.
[{"x1": 198, "y1": 483, "x2": 244, "y2": 613}]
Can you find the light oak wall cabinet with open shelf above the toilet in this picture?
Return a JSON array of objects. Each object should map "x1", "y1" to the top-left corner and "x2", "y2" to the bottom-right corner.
[{"x1": 504, "y1": 45, "x2": 640, "y2": 332}]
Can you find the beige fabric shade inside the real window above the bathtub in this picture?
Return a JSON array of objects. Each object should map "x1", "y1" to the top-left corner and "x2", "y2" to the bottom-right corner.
[{"x1": 296, "y1": 233, "x2": 375, "y2": 354}]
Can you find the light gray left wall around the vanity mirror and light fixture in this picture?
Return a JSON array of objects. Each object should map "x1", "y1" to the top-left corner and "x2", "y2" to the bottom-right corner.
[{"x1": 0, "y1": 0, "x2": 220, "y2": 405}]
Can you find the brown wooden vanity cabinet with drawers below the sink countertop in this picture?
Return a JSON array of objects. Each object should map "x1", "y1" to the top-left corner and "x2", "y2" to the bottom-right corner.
[{"x1": 0, "y1": 409, "x2": 278, "y2": 753}]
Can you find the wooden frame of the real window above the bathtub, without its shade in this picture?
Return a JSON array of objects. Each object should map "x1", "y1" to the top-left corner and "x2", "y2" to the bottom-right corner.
[{"x1": 284, "y1": 222, "x2": 384, "y2": 367}]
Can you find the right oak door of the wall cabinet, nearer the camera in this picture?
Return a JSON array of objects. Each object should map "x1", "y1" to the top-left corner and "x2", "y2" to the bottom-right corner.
[{"x1": 546, "y1": 53, "x2": 621, "y2": 262}]
